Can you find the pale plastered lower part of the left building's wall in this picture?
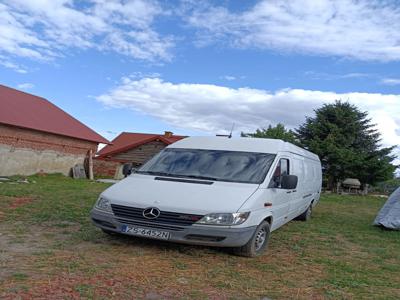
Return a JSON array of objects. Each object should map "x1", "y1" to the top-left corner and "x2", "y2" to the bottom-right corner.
[{"x1": 0, "y1": 144, "x2": 85, "y2": 176}]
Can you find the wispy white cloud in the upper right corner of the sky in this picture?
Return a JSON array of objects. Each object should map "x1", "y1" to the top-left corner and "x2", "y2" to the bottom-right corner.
[{"x1": 187, "y1": 0, "x2": 400, "y2": 61}]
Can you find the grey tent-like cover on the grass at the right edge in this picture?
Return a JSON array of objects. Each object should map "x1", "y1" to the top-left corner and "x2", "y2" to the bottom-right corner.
[{"x1": 374, "y1": 187, "x2": 400, "y2": 230}]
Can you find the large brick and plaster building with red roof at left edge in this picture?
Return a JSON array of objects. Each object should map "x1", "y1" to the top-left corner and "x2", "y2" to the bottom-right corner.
[{"x1": 0, "y1": 85, "x2": 109, "y2": 176}]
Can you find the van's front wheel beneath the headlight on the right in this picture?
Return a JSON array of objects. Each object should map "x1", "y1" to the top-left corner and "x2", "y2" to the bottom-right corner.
[{"x1": 233, "y1": 221, "x2": 270, "y2": 257}]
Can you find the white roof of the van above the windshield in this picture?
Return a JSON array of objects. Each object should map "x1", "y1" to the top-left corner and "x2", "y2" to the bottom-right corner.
[{"x1": 168, "y1": 136, "x2": 319, "y2": 161}]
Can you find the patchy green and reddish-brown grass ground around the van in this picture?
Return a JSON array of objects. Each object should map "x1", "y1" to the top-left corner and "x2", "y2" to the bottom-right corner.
[{"x1": 0, "y1": 175, "x2": 400, "y2": 299}]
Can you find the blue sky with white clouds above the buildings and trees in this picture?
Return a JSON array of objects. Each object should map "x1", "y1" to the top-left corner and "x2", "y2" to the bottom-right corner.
[{"x1": 0, "y1": 0, "x2": 400, "y2": 159}]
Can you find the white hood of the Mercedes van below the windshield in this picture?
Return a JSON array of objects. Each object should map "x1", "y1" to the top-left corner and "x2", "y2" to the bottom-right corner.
[{"x1": 102, "y1": 174, "x2": 259, "y2": 214}]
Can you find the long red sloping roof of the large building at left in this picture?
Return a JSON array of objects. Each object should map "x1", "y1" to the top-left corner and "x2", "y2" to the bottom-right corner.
[{"x1": 0, "y1": 85, "x2": 109, "y2": 144}]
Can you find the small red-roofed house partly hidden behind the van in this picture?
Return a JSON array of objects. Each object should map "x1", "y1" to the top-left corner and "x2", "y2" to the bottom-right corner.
[{"x1": 93, "y1": 131, "x2": 185, "y2": 178}]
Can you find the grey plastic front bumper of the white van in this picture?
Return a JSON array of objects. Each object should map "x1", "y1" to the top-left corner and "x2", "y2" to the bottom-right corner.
[{"x1": 90, "y1": 208, "x2": 256, "y2": 247}]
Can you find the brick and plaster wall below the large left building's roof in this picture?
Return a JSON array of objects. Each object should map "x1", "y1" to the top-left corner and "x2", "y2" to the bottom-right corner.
[{"x1": 0, "y1": 124, "x2": 97, "y2": 176}]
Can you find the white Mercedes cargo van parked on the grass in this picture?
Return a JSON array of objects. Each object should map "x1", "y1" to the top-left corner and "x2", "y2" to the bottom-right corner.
[{"x1": 91, "y1": 137, "x2": 322, "y2": 257}]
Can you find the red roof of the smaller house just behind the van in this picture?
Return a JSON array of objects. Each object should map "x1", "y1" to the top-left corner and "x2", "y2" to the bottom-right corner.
[{"x1": 97, "y1": 132, "x2": 186, "y2": 157}]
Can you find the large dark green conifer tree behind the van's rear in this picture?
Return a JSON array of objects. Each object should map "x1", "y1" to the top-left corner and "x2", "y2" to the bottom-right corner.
[{"x1": 296, "y1": 101, "x2": 396, "y2": 188}]
